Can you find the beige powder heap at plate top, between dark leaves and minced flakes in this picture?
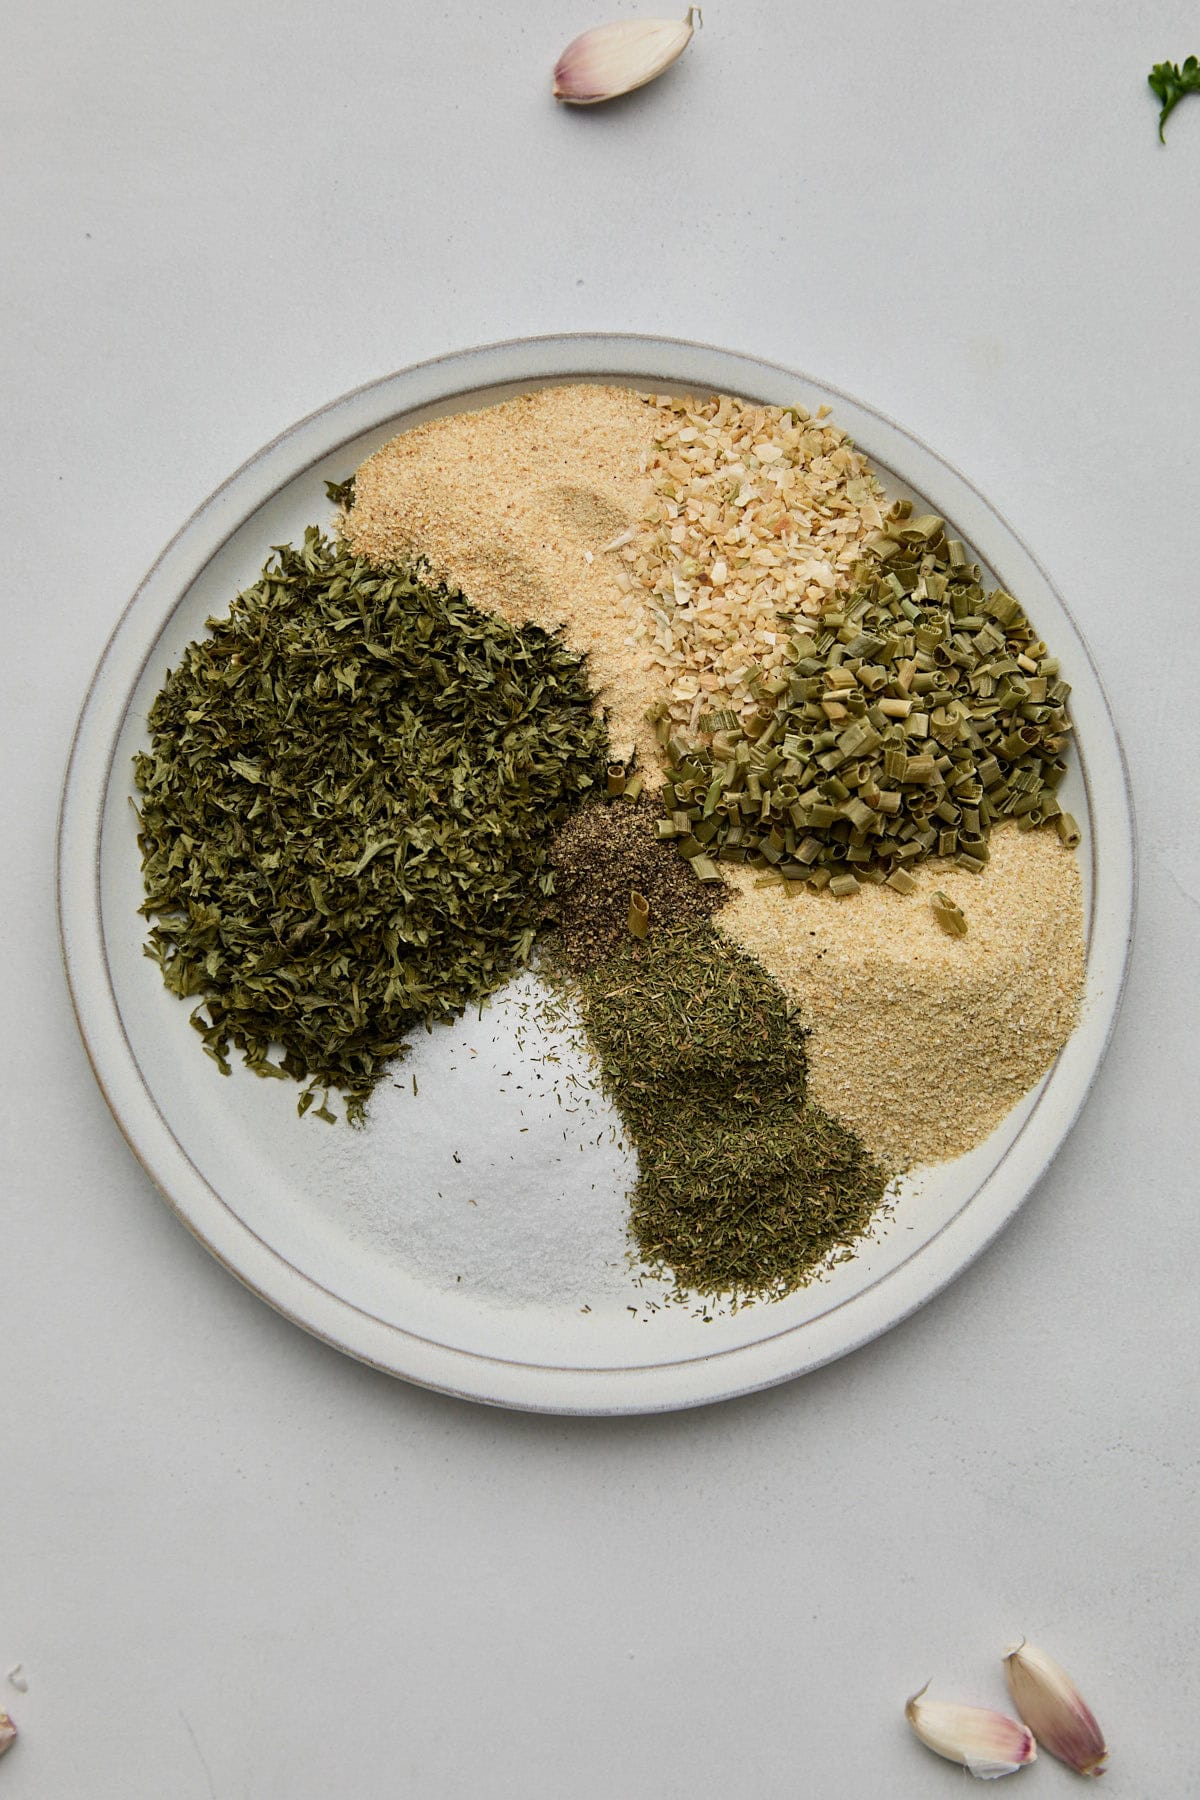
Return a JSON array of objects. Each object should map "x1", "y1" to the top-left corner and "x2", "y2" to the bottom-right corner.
[{"x1": 345, "y1": 383, "x2": 660, "y2": 781}]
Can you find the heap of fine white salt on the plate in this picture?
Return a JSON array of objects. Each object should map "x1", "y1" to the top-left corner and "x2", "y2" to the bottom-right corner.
[{"x1": 322, "y1": 972, "x2": 637, "y2": 1309}]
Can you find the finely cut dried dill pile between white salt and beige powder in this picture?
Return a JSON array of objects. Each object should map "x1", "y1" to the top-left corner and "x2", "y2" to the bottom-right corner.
[{"x1": 554, "y1": 922, "x2": 887, "y2": 1305}]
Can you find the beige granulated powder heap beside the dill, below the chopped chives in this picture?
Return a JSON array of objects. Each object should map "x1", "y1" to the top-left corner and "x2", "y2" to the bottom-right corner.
[{"x1": 716, "y1": 826, "x2": 1083, "y2": 1170}]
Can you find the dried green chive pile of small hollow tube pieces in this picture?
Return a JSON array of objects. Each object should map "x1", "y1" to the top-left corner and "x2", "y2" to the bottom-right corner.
[{"x1": 657, "y1": 506, "x2": 1074, "y2": 895}]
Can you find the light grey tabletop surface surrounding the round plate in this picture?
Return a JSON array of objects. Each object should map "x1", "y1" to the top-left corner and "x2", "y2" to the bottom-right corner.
[{"x1": 0, "y1": 0, "x2": 1200, "y2": 1800}]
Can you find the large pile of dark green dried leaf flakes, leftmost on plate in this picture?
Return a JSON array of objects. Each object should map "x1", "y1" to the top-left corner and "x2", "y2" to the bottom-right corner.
[{"x1": 135, "y1": 527, "x2": 606, "y2": 1118}]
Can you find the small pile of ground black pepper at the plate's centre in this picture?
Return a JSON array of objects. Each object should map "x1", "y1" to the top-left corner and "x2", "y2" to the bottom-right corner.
[{"x1": 551, "y1": 796, "x2": 729, "y2": 970}]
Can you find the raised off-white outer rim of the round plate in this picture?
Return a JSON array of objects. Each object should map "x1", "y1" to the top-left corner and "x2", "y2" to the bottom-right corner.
[{"x1": 56, "y1": 331, "x2": 1137, "y2": 1417}]
